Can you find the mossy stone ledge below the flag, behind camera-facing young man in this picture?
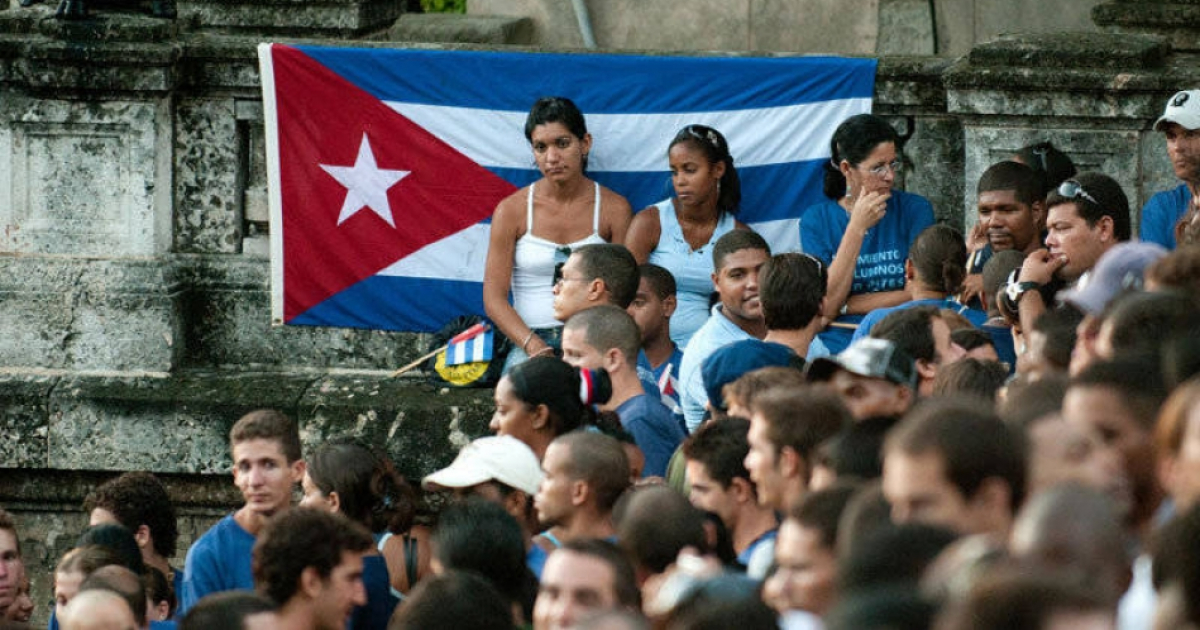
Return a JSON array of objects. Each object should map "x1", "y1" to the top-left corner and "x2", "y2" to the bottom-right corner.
[{"x1": 0, "y1": 371, "x2": 492, "y2": 477}]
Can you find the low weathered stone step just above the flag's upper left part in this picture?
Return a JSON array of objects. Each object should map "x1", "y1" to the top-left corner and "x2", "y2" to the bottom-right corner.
[{"x1": 386, "y1": 13, "x2": 533, "y2": 46}]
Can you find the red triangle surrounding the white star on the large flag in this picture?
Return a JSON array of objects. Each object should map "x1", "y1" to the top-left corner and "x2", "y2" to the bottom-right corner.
[{"x1": 271, "y1": 44, "x2": 516, "y2": 322}]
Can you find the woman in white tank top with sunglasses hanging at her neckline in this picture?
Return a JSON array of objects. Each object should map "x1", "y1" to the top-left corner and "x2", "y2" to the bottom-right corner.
[{"x1": 484, "y1": 96, "x2": 632, "y2": 371}]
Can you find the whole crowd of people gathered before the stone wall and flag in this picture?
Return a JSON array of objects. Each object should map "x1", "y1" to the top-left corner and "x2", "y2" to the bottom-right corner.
[{"x1": 0, "y1": 90, "x2": 1200, "y2": 630}]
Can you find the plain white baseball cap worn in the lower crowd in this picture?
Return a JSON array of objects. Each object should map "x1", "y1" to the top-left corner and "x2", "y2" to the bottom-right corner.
[{"x1": 421, "y1": 436, "x2": 542, "y2": 496}]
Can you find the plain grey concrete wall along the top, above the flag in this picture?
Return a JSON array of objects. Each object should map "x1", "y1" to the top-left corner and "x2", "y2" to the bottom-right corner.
[{"x1": 467, "y1": 0, "x2": 1102, "y2": 55}]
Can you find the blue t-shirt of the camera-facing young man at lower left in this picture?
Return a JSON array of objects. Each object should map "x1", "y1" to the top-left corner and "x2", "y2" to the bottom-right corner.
[{"x1": 175, "y1": 514, "x2": 254, "y2": 619}]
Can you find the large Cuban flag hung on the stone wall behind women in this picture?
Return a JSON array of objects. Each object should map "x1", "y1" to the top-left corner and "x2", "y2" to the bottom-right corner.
[{"x1": 259, "y1": 44, "x2": 875, "y2": 331}]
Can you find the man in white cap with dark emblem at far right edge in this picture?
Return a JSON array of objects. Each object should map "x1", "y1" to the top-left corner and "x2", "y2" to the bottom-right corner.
[{"x1": 1139, "y1": 90, "x2": 1200, "y2": 250}]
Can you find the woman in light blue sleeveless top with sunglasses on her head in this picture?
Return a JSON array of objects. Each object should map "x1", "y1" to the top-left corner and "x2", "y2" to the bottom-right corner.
[{"x1": 626, "y1": 125, "x2": 749, "y2": 348}]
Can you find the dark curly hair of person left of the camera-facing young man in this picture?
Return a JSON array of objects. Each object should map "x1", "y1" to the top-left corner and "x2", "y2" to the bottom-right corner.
[{"x1": 83, "y1": 472, "x2": 179, "y2": 558}]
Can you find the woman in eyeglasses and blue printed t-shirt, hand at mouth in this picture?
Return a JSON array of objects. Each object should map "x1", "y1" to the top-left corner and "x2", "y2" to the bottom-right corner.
[{"x1": 800, "y1": 114, "x2": 934, "y2": 354}]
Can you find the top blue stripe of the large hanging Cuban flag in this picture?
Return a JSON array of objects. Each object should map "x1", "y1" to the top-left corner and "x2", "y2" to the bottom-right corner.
[{"x1": 290, "y1": 46, "x2": 876, "y2": 114}]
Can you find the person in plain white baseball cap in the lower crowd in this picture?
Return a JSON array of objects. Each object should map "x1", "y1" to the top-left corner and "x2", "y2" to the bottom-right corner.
[{"x1": 421, "y1": 436, "x2": 547, "y2": 576}]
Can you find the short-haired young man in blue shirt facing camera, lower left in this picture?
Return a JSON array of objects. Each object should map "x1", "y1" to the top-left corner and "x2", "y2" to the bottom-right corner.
[{"x1": 176, "y1": 409, "x2": 305, "y2": 617}]
